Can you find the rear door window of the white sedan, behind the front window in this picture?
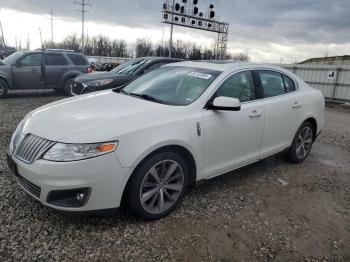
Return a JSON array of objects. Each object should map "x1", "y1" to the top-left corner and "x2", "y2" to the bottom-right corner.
[{"x1": 259, "y1": 71, "x2": 285, "y2": 97}]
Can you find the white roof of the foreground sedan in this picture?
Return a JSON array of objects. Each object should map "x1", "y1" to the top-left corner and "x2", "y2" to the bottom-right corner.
[{"x1": 166, "y1": 61, "x2": 286, "y2": 72}]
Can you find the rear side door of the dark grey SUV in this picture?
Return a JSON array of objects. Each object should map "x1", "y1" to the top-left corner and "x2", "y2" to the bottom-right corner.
[{"x1": 44, "y1": 53, "x2": 68, "y2": 88}]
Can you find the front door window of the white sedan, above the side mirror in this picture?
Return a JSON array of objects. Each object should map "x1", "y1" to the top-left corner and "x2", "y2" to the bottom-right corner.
[{"x1": 215, "y1": 71, "x2": 256, "y2": 102}]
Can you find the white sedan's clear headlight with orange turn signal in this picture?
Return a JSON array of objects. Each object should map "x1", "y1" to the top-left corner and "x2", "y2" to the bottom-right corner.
[{"x1": 43, "y1": 141, "x2": 118, "y2": 162}]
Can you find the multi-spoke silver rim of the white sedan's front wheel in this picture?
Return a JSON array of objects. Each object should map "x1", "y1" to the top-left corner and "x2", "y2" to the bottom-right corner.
[{"x1": 140, "y1": 160, "x2": 184, "y2": 214}]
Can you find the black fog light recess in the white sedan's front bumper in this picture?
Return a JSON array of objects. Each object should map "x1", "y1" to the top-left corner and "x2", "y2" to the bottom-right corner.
[{"x1": 47, "y1": 188, "x2": 91, "y2": 207}]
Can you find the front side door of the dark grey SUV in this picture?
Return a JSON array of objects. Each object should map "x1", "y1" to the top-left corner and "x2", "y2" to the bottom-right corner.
[{"x1": 12, "y1": 53, "x2": 42, "y2": 89}]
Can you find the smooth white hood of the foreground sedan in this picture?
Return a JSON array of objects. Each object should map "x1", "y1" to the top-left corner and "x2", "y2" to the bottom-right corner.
[{"x1": 23, "y1": 91, "x2": 176, "y2": 143}]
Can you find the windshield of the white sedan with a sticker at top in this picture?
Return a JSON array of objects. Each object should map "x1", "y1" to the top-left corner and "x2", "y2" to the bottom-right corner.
[{"x1": 122, "y1": 66, "x2": 221, "y2": 106}]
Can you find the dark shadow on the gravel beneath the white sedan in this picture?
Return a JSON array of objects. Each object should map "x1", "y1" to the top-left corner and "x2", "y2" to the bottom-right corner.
[{"x1": 20, "y1": 155, "x2": 287, "y2": 226}]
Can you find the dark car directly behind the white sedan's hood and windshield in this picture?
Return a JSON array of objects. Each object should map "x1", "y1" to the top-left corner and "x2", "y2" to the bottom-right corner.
[{"x1": 71, "y1": 57, "x2": 181, "y2": 95}]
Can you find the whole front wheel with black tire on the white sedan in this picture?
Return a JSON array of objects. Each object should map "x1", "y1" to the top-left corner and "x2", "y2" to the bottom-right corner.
[{"x1": 126, "y1": 152, "x2": 189, "y2": 220}]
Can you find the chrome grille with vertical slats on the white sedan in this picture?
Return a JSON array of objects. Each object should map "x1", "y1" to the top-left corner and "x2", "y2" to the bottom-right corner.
[{"x1": 15, "y1": 134, "x2": 55, "y2": 164}]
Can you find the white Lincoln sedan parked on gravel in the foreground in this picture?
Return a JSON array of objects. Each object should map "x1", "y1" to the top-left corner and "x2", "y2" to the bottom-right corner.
[{"x1": 8, "y1": 62, "x2": 324, "y2": 219}]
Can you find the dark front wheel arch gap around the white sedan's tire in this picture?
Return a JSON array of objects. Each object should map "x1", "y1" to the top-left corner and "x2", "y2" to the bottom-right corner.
[{"x1": 121, "y1": 144, "x2": 197, "y2": 208}]
